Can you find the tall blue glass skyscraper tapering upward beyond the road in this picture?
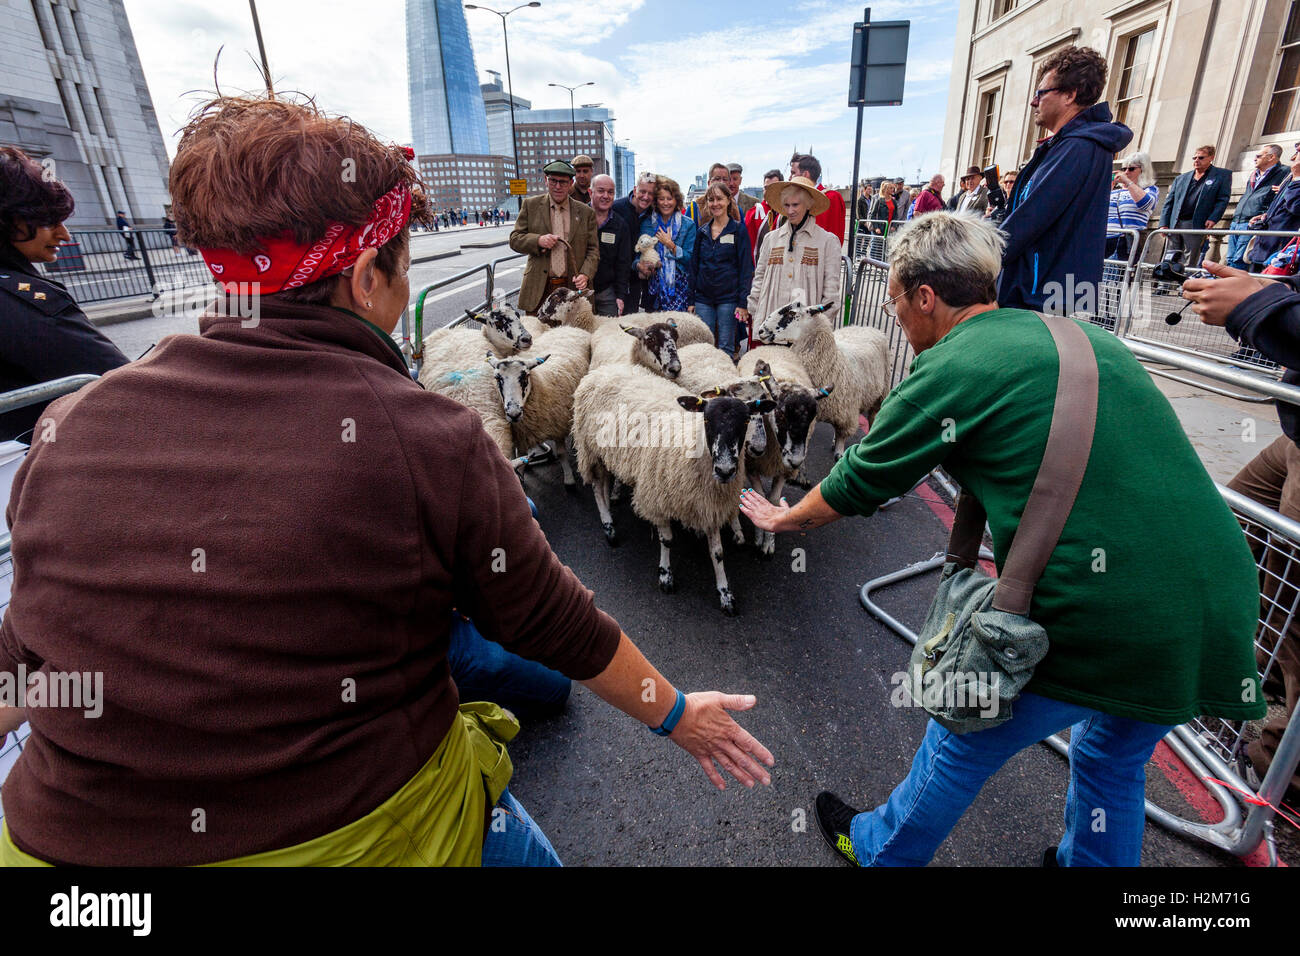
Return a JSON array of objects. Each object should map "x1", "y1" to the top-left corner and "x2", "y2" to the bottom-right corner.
[{"x1": 407, "y1": 0, "x2": 490, "y2": 156}]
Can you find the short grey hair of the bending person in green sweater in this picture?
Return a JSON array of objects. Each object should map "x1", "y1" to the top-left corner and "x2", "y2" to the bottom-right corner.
[{"x1": 889, "y1": 209, "x2": 1006, "y2": 308}]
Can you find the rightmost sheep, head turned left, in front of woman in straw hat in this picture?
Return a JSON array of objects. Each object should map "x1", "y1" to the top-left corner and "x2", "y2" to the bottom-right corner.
[{"x1": 758, "y1": 290, "x2": 889, "y2": 460}]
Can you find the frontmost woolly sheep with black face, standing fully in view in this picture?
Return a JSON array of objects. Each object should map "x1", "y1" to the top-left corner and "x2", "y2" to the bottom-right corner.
[{"x1": 573, "y1": 365, "x2": 775, "y2": 614}]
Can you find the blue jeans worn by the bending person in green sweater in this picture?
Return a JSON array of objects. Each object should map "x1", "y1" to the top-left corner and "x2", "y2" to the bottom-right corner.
[{"x1": 849, "y1": 693, "x2": 1170, "y2": 866}]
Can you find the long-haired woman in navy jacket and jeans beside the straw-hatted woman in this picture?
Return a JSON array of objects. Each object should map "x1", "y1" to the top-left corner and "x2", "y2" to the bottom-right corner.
[{"x1": 690, "y1": 183, "x2": 754, "y2": 355}]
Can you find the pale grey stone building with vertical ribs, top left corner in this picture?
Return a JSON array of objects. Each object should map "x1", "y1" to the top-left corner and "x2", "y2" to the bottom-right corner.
[{"x1": 0, "y1": 0, "x2": 170, "y2": 229}]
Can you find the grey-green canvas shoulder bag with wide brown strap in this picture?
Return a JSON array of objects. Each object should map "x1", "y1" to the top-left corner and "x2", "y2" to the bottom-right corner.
[{"x1": 906, "y1": 316, "x2": 1097, "y2": 734}]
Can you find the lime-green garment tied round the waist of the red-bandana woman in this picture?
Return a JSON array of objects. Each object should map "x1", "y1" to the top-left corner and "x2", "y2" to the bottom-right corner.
[{"x1": 0, "y1": 701, "x2": 519, "y2": 866}]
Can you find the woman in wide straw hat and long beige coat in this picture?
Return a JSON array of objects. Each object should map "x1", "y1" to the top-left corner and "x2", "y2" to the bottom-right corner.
[{"x1": 749, "y1": 176, "x2": 840, "y2": 323}]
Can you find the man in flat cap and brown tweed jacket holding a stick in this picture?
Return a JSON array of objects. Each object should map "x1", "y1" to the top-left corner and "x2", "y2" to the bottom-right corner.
[{"x1": 510, "y1": 160, "x2": 599, "y2": 315}]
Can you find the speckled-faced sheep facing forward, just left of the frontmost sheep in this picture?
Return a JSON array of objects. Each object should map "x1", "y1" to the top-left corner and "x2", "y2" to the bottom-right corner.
[{"x1": 488, "y1": 328, "x2": 592, "y2": 489}]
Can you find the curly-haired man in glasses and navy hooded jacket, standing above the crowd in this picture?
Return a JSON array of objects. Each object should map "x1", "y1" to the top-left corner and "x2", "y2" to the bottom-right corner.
[{"x1": 997, "y1": 47, "x2": 1134, "y2": 315}]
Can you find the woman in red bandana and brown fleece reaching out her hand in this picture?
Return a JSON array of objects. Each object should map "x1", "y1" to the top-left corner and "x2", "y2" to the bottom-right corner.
[{"x1": 0, "y1": 99, "x2": 772, "y2": 866}]
